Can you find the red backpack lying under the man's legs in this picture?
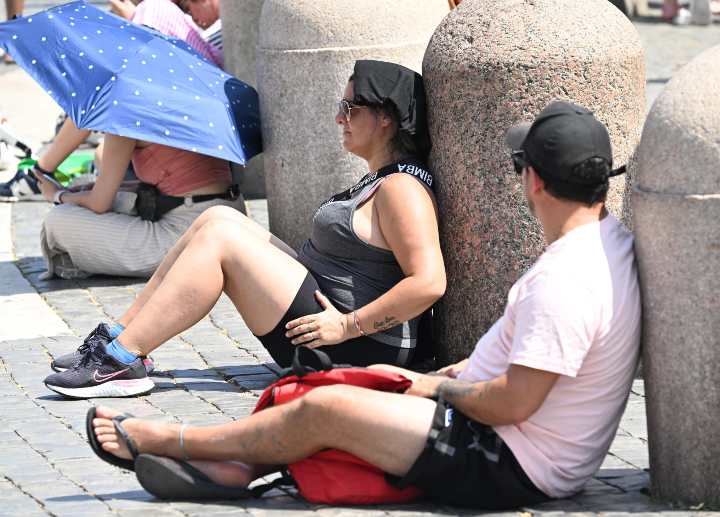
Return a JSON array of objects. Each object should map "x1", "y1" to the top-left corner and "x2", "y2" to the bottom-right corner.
[{"x1": 254, "y1": 347, "x2": 422, "y2": 504}]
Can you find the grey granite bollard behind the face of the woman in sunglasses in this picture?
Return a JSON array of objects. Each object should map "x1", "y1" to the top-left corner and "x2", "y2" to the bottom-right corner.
[{"x1": 257, "y1": 0, "x2": 450, "y2": 247}]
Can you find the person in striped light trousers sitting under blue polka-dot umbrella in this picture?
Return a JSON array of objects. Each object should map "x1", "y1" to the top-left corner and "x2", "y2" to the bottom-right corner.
[{"x1": 34, "y1": 119, "x2": 245, "y2": 278}]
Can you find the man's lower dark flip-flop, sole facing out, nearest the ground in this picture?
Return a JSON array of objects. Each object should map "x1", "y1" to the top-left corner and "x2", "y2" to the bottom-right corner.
[{"x1": 135, "y1": 454, "x2": 262, "y2": 501}]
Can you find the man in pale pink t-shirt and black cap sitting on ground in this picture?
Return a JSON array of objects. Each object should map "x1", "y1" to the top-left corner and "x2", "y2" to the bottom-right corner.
[{"x1": 86, "y1": 102, "x2": 640, "y2": 509}]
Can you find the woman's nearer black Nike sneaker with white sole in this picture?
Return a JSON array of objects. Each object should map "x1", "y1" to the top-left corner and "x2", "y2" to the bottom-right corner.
[{"x1": 44, "y1": 342, "x2": 155, "y2": 399}]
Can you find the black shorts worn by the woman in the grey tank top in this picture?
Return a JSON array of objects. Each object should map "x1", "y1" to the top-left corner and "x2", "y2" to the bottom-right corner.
[{"x1": 255, "y1": 273, "x2": 414, "y2": 368}]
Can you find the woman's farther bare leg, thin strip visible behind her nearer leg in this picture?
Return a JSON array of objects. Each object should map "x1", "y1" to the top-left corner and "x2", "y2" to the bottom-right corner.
[{"x1": 118, "y1": 206, "x2": 297, "y2": 327}]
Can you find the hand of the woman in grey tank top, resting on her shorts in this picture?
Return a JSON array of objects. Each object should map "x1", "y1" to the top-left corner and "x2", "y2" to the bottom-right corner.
[{"x1": 285, "y1": 291, "x2": 352, "y2": 348}]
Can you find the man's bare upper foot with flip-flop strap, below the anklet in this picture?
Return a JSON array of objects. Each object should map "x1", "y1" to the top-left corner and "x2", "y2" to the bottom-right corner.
[{"x1": 93, "y1": 406, "x2": 180, "y2": 460}]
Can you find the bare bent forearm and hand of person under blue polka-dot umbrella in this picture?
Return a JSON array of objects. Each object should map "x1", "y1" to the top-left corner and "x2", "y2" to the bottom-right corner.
[{"x1": 37, "y1": 135, "x2": 137, "y2": 214}]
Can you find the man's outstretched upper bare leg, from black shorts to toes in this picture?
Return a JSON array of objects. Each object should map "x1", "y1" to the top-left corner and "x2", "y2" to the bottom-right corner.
[{"x1": 93, "y1": 385, "x2": 435, "y2": 476}]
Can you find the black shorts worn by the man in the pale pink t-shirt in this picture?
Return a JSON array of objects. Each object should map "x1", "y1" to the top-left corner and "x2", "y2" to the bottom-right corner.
[{"x1": 387, "y1": 399, "x2": 549, "y2": 510}]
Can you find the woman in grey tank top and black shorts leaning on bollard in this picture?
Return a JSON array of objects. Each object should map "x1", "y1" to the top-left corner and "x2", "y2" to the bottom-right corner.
[{"x1": 45, "y1": 61, "x2": 445, "y2": 398}]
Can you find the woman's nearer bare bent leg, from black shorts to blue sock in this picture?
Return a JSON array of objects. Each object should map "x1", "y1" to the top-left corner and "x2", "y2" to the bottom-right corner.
[{"x1": 118, "y1": 214, "x2": 307, "y2": 355}]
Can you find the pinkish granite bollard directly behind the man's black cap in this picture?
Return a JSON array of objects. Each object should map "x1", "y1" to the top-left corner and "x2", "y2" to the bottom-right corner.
[{"x1": 423, "y1": 0, "x2": 645, "y2": 362}]
